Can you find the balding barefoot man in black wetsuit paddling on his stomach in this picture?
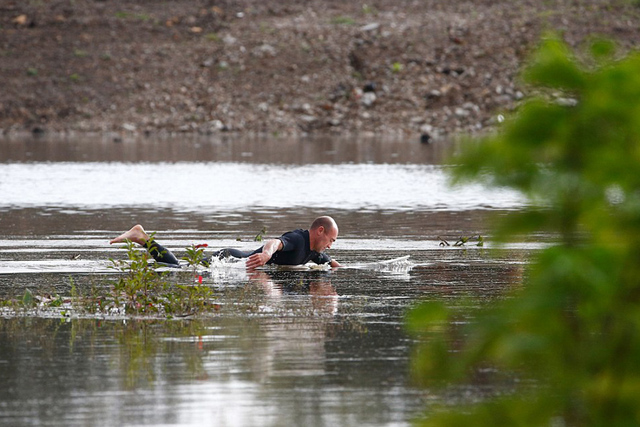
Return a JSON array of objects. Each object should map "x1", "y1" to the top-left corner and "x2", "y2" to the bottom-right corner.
[{"x1": 109, "y1": 216, "x2": 340, "y2": 270}]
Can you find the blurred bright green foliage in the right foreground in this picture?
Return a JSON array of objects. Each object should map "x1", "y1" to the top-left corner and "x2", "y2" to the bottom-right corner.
[{"x1": 407, "y1": 35, "x2": 640, "y2": 426}]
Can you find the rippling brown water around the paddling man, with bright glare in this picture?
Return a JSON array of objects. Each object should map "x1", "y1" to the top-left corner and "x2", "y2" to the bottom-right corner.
[{"x1": 0, "y1": 137, "x2": 541, "y2": 426}]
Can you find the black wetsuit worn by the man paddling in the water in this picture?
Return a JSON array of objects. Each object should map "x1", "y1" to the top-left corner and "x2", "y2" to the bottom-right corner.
[{"x1": 146, "y1": 229, "x2": 331, "y2": 267}]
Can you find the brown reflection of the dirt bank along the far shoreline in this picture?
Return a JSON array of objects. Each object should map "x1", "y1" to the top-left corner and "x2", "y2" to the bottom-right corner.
[{"x1": 0, "y1": 135, "x2": 450, "y2": 165}]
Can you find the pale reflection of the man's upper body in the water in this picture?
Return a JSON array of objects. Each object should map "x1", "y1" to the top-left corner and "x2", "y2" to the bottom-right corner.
[{"x1": 241, "y1": 269, "x2": 339, "y2": 386}]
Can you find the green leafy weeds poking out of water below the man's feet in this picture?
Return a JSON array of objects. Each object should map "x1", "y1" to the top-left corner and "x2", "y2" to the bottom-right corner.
[{"x1": 0, "y1": 236, "x2": 219, "y2": 318}]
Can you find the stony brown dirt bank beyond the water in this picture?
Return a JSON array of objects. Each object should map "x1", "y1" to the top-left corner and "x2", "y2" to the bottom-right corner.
[{"x1": 0, "y1": 0, "x2": 640, "y2": 138}]
